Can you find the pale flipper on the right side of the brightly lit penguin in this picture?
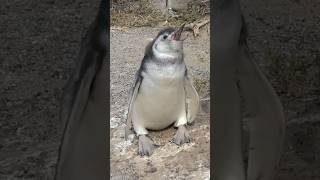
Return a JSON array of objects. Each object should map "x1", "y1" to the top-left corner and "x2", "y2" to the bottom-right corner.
[{"x1": 184, "y1": 76, "x2": 200, "y2": 123}]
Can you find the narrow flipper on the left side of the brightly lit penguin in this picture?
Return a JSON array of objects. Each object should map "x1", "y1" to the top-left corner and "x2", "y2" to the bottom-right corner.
[{"x1": 125, "y1": 74, "x2": 142, "y2": 140}]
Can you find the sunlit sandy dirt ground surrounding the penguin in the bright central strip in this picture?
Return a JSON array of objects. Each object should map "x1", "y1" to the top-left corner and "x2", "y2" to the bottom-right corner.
[{"x1": 110, "y1": 27, "x2": 210, "y2": 180}]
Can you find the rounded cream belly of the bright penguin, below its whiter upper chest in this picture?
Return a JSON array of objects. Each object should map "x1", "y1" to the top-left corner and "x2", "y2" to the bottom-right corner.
[{"x1": 134, "y1": 79, "x2": 185, "y2": 130}]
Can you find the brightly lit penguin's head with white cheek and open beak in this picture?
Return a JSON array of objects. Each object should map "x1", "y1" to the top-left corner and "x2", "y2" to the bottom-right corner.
[{"x1": 152, "y1": 24, "x2": 184, "y2": 58}]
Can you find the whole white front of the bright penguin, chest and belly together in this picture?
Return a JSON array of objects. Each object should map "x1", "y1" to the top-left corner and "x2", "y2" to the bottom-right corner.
[{"x1": 135, "y1": 64, "x2": 185, "y2": 130}]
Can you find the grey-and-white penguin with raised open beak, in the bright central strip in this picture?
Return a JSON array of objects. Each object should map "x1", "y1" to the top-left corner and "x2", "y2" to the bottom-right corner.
[{"x1": 125, "y1": 25, "x2": 199, "y2": 156}]
